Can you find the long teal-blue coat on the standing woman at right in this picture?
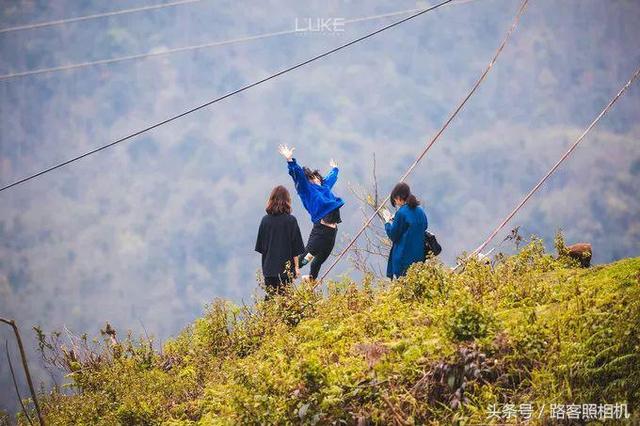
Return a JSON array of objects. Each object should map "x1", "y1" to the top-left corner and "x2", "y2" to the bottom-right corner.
[{"x1": 384, "y1": 204, "x2": 428, "y2": 278}]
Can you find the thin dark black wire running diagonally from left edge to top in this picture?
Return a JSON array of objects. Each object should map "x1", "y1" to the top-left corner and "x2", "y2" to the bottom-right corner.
[{"x1": 0, "y1": 0, "x2": 456, "y2": 192}]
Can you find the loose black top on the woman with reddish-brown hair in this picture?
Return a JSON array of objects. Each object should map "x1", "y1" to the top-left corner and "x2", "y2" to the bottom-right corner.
[{"x1": 256, "y1": 214, "x2": 304, "y2": 277}]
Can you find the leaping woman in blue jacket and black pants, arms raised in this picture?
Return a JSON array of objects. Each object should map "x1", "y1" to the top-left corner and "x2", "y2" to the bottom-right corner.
[{"x1": 278, "y1": 145, "x2": 344, "y2": 279}]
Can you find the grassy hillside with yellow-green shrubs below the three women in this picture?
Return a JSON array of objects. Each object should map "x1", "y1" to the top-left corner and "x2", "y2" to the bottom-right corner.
[{"x1": 17, "y1": 240, "x2": 640, "y2": 425}]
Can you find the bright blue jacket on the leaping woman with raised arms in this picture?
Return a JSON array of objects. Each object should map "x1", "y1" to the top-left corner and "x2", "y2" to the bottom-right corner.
[{"x1": 287, "y1": 158, "x2": 344, "y2": 223}]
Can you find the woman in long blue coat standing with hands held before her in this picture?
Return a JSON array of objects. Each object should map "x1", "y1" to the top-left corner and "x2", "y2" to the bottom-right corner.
[{"x1": 383, "y1": 182, "x2": 428, "y2": 278}]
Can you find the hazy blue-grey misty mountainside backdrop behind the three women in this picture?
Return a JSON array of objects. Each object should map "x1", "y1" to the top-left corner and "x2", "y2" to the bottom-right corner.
[{"x1": 0, "y1": 0, "x2": 640, "y2": 414}]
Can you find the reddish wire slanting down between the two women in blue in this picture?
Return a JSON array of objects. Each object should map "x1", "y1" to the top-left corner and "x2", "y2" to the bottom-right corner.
[{"x1": 315, "y1": 0, "x2": 529, "y2": 285}]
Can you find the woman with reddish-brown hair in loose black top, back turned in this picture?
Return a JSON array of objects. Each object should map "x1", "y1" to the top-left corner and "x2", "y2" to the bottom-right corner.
[{"x1": 256, "y1": 186, "x2": 304, "y2": 299}]
